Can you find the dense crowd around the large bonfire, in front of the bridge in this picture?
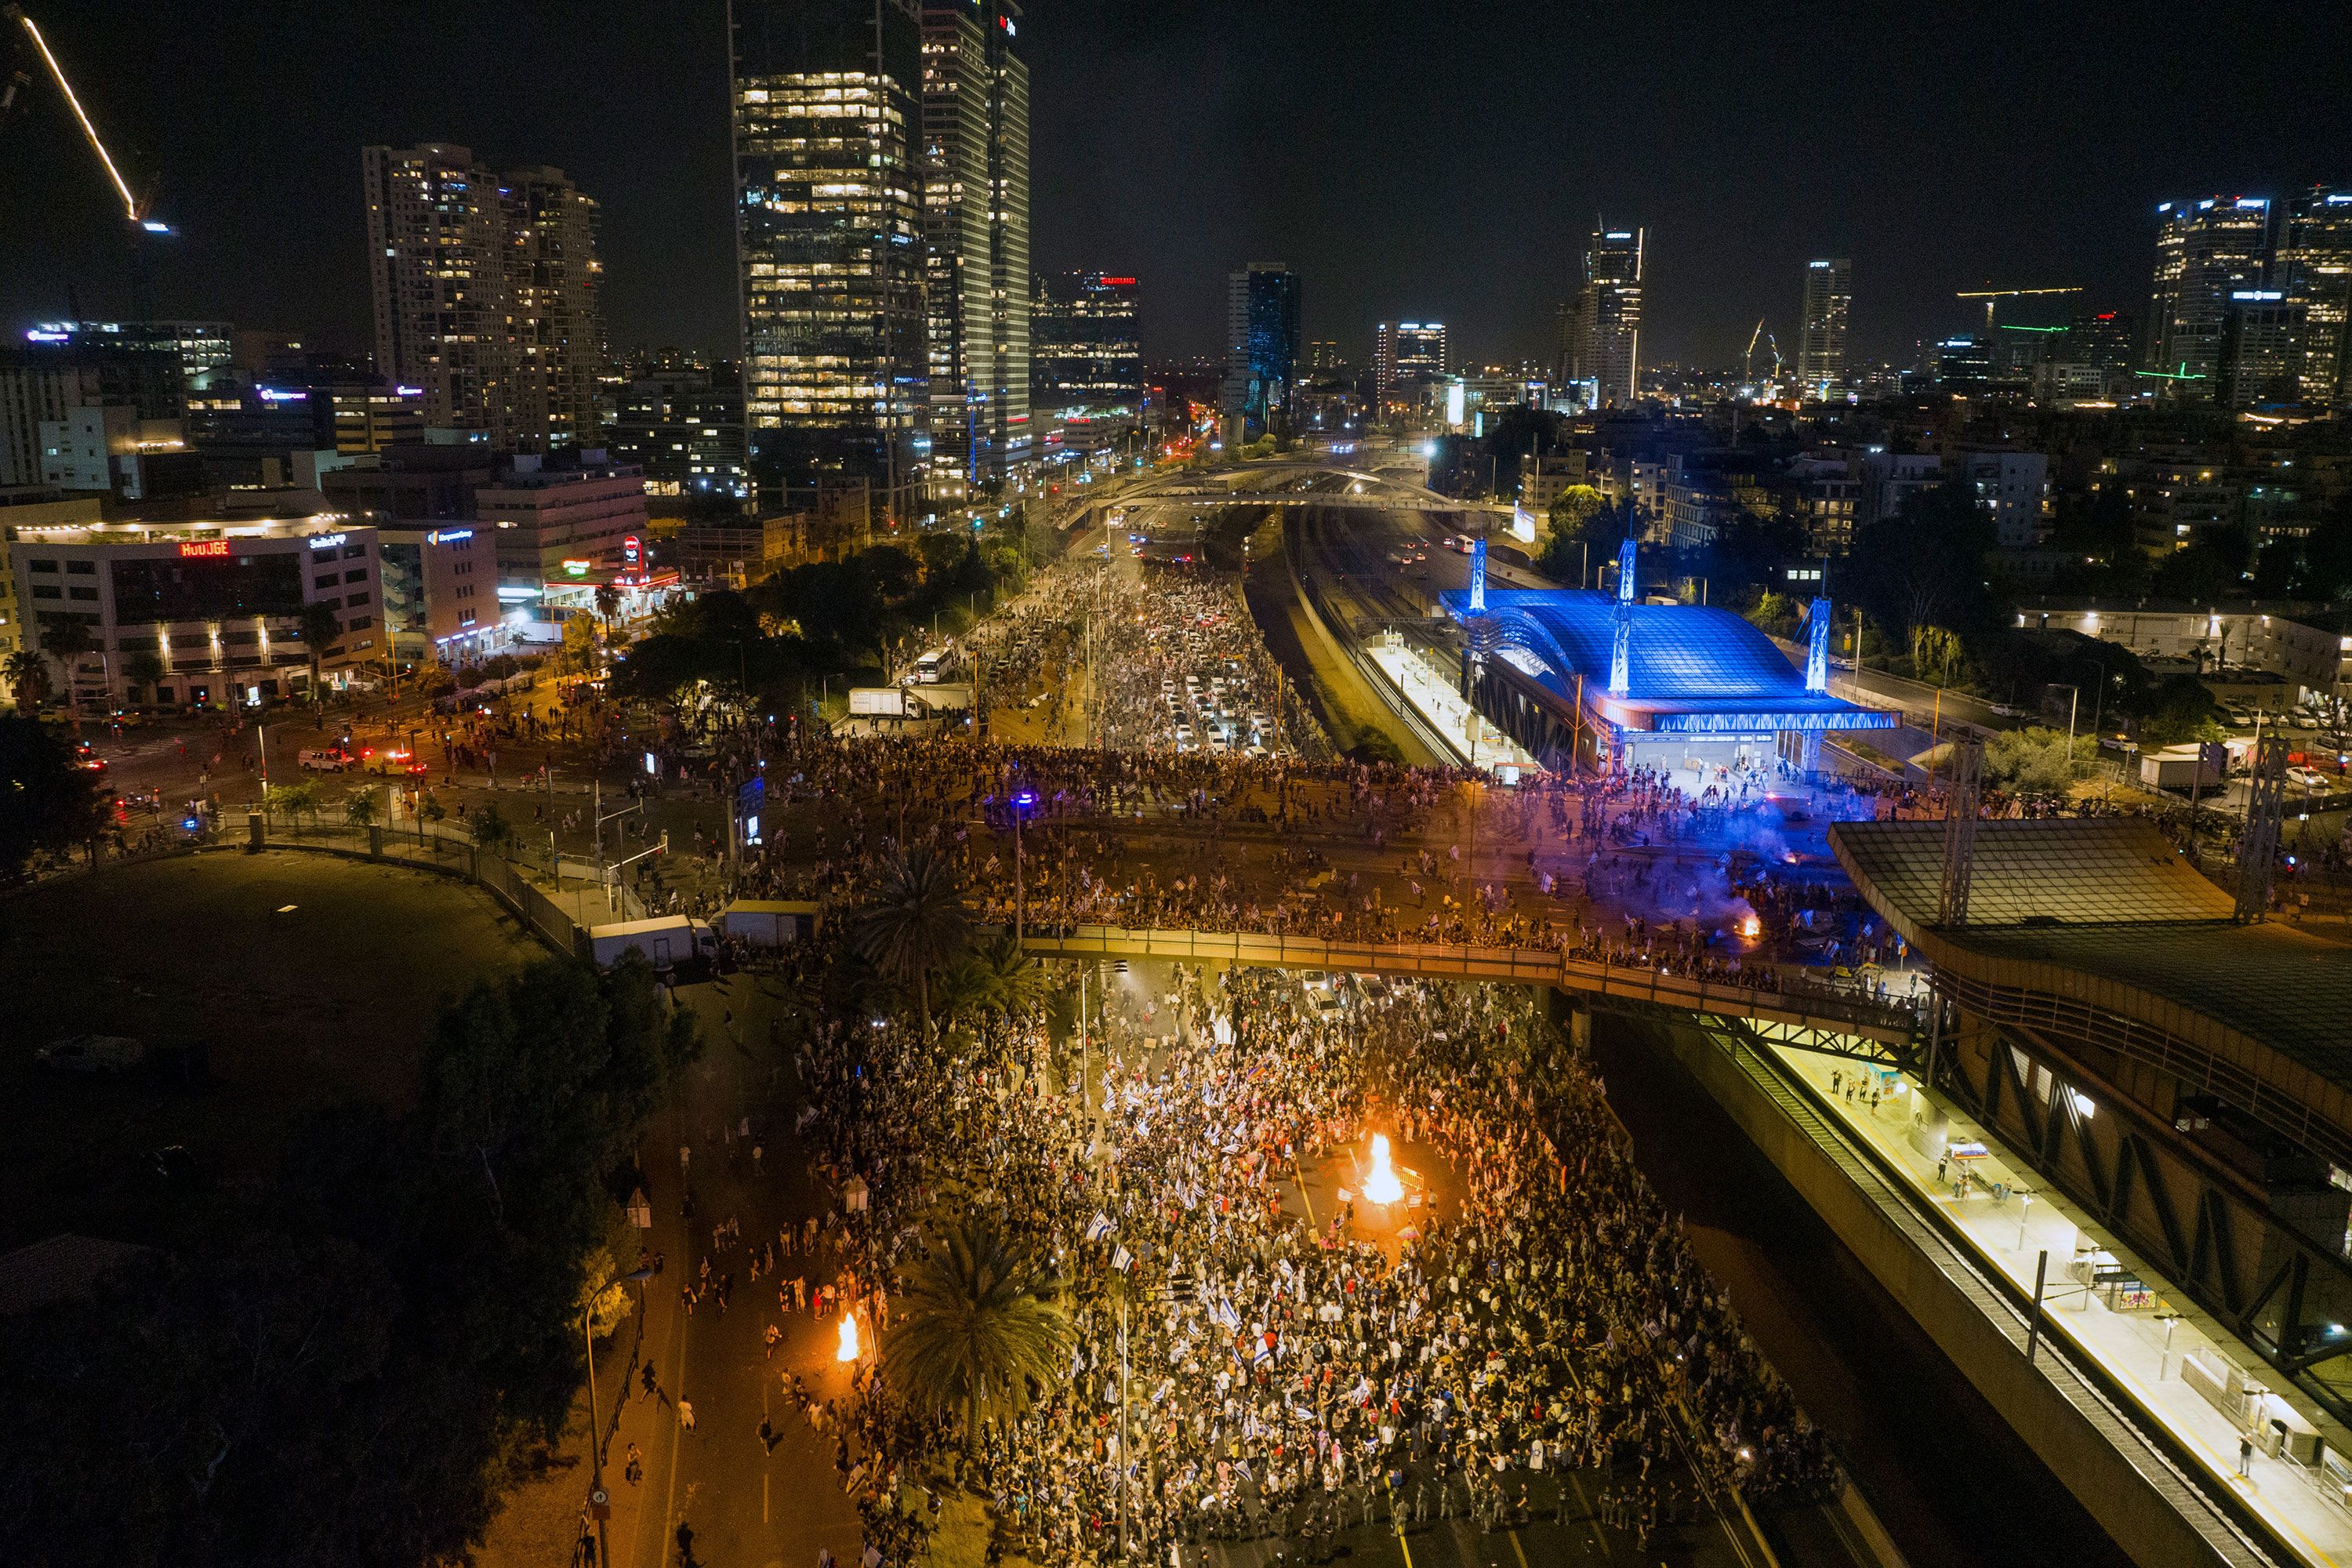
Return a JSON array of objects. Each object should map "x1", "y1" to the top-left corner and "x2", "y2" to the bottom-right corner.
[{"x1": 781, "y1": 949, "x2": 1832, "y2": 1563}]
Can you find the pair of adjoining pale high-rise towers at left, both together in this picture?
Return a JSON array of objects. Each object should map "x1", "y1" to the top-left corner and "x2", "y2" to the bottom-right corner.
[{"x1": 360, "y1": 141, "x2": 604, "y2": 449}]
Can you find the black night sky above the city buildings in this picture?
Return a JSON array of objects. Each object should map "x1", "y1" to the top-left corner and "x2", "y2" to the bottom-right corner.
[{"x1": 0, "y1": 0, "x2": 2352, "y2": 362}]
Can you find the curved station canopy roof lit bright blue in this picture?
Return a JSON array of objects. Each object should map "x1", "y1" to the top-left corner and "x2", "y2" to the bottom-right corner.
[{"x1": 1442, "y1": 588, "x2": 1903, "y2": 736}]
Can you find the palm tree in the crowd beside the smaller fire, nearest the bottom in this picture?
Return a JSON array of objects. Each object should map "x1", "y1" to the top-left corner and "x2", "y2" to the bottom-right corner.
[{"x1": 882, "y1": 1218, "x2": 1073, "y2": 1453}]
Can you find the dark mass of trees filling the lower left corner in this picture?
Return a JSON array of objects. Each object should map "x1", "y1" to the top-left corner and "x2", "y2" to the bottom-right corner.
[{"x1": 0, "y1": 961, "x2": 696, "y2": 1568}]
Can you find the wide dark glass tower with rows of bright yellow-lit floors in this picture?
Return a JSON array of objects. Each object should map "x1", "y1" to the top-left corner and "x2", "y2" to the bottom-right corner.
[{"x1": 729, "y1": 0, "x2": 922, "y2": 517}]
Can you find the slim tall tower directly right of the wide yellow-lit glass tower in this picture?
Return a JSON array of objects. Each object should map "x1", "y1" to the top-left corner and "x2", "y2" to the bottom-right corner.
[{"x1": 922, "y1": 0, "x2": 1033, "y2": 499}]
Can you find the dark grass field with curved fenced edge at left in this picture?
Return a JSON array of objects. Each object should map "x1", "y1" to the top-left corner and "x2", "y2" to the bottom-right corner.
[{"x1": 0, "y1": 851, "x2": 543, "y2": 1250}]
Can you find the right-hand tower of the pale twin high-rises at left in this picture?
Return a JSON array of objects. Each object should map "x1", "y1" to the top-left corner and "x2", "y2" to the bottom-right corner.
[{"x1": 499, "y1": 169, "x2": 604, "y2": 447}]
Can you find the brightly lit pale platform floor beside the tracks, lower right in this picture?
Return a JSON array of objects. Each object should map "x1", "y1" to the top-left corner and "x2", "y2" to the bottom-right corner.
[{"x1": 1769, "y1": 1046, "x2": 2352, "y2": 1568}]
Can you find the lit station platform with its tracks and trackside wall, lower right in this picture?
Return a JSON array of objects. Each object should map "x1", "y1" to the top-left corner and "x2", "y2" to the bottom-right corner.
[{"x1": 1677, "y1": 1025, "x2": 2314, "y2": 1568}]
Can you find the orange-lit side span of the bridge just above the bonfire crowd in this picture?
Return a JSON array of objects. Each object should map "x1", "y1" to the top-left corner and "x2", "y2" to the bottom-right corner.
[{"x1": 1021, "y1": 926, "x2": 1915, "y2": 1055}]
